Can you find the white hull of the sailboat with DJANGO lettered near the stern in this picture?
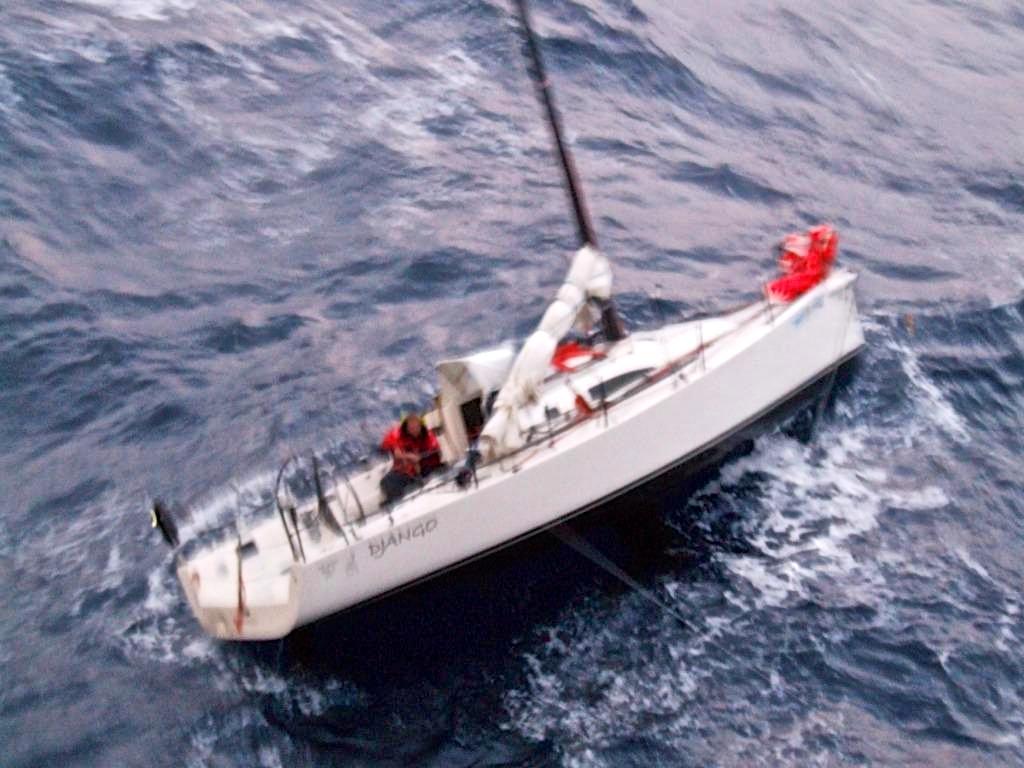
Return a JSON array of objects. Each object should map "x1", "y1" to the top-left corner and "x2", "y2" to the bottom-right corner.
[{"x1": 178, "y1": 270, "x2": 863, "y2": 640}]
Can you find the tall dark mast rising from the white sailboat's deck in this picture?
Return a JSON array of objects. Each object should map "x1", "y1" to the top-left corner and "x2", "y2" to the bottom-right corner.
[{"x1": 513, "y1": 0, "x2": 627, "y2": 341}]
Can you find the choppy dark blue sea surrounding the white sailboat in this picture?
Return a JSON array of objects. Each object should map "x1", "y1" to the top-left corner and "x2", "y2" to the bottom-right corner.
[{"x1": 0, "y1": 0, "x2": 1024, "y2": 768}]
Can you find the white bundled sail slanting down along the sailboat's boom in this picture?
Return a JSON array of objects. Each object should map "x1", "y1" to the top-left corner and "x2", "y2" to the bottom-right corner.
[{"x1": 480, "y1": 245, "x2": 611, "y2": 459}]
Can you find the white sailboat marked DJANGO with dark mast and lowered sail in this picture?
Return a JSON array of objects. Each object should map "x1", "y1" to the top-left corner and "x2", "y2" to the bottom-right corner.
[{"x1": 153, "y1": 0, "x2": 864, "y2": 640}]
